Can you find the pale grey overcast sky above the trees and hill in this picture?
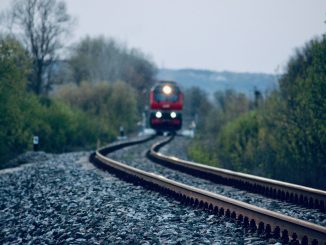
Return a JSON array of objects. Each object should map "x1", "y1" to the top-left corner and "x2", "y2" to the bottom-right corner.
[{"x1": 0, "y1": 0, "x2": 326, "y2": 73}]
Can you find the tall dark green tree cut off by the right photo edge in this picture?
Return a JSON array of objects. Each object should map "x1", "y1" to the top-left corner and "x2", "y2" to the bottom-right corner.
[{"x1": 278, "y1": 35, "x2": 326, "y2": 186}]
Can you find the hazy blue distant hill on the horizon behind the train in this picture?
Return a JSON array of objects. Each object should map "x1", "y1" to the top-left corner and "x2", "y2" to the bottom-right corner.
[{"x1": 157, "y1": 69, "x2": 278, "y2": 96}]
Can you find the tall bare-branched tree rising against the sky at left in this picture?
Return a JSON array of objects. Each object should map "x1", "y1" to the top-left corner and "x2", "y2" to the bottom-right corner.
[{"x1": 3, "y1": 0, "x2": 72, "y2": 95}]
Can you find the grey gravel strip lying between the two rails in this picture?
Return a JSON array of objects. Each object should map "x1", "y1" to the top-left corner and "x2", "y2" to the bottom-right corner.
[{"x1": 109, "y1": 137, "x2": 326, "y2": 226}]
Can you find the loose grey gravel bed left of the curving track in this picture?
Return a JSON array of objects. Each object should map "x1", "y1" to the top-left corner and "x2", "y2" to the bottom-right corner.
[{"x1": 0, "y1": 148, "x2": 275, "y2": 245}]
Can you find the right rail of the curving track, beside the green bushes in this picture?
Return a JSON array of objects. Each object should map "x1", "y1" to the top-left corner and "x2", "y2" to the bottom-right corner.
[{"x1": 148, "y1": 136, "x2": 326, "y2": 211}]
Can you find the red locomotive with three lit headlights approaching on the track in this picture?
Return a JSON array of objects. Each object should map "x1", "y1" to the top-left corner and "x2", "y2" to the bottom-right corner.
[{"x1": 149, "y1": 81, "x2": 184, "y2": 134}]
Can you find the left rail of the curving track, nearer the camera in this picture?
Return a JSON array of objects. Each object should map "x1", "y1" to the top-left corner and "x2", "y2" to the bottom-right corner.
[{"x1": 90, "y1": 137, "x2": 326, "y2": 244}]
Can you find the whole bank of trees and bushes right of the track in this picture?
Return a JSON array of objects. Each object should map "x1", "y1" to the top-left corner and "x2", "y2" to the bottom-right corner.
[{"x1": 188, "y1": 35, "x2": 326, "y2": 189}]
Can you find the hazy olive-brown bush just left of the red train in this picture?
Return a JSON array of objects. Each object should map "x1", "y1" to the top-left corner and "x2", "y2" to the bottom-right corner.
[{"x1": 55, "y1": 81, "x2": 138, "y2": 132}]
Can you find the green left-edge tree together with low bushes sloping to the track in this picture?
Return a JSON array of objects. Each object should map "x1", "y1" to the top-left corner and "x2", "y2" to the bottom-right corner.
[{"x1": 0, "y1": 37, "x2": 116, "y2": 168}]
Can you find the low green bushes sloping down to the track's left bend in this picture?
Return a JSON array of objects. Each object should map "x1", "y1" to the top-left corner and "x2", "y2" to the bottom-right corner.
[{"x1": 30, "y1": 98, "x2": 115, "y2": 152}]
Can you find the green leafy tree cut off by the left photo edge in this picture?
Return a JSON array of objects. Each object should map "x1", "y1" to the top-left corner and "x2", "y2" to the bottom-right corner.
[{"x1": 0, "y1": 37, "x2": 29, "y2": 165}]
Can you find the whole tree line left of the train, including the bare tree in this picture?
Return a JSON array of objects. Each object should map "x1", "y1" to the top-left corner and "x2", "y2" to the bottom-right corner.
[{"x1": 0, "y1": 0, "x2": 156, "y2": 168}]
